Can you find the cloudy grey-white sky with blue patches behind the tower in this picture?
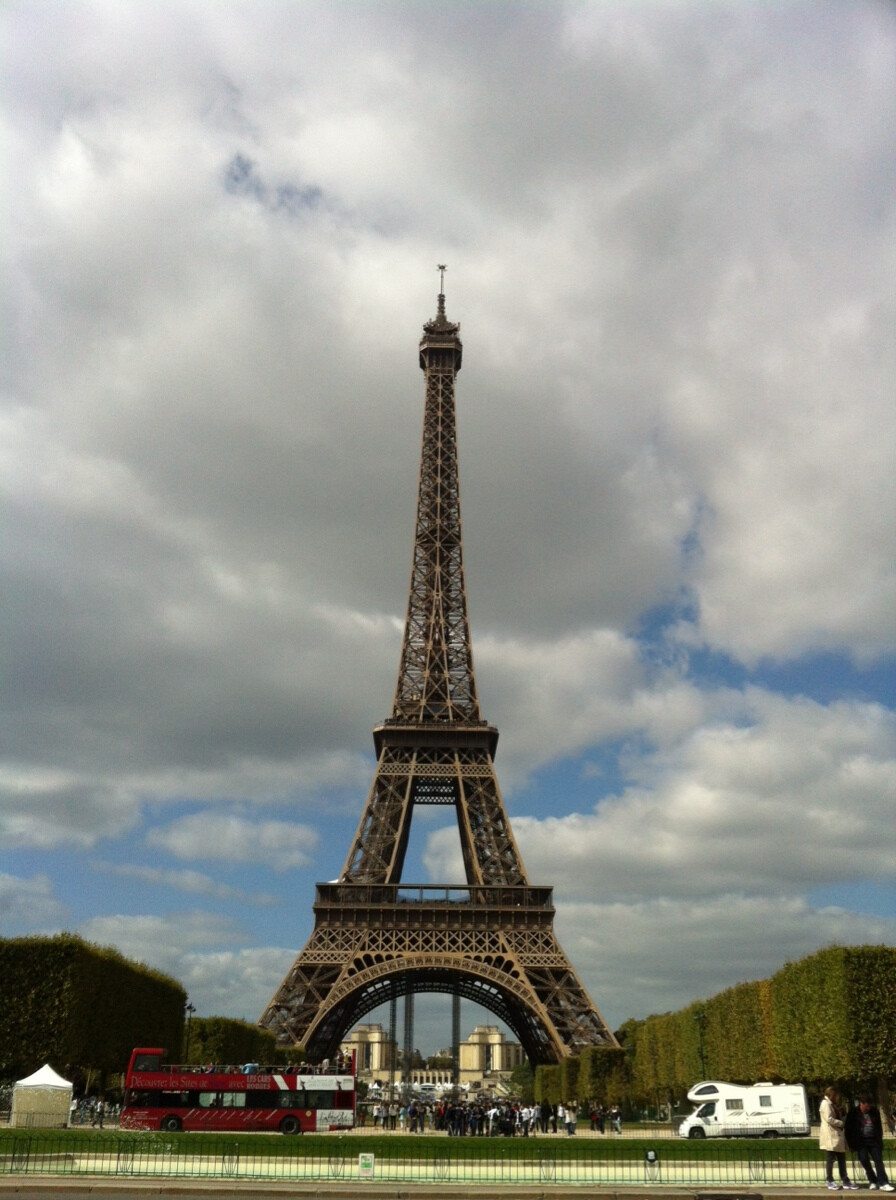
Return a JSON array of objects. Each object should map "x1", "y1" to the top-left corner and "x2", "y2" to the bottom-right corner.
[{"x1": 0, "y1": 0, "x2": 896, "y2": 1050}]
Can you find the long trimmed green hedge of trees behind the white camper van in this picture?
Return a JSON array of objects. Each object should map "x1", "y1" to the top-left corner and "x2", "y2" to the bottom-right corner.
[{"x1": 549, "y1": 946, "x2": 896, "y2": 1111}]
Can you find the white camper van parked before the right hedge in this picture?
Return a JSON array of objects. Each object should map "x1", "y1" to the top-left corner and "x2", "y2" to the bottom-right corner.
[{"x1": 678, "y1": 1080, "x2": 810, "y2": 1138}]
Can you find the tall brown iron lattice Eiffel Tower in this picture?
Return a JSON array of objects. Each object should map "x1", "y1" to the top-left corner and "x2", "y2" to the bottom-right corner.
[{"x1": 259, "y1": 274, "x2": 618, "y2": 1066}]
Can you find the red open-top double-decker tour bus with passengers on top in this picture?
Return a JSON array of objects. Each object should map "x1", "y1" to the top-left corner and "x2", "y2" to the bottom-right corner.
[{"x1": 121, "y1": 1049, "x2": 355, "y2": 1134}]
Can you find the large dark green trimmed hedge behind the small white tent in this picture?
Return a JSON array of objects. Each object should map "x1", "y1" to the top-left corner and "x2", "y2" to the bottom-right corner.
[{"x1": 0, "y1": 934, "x2": 187, "y2": 1079}]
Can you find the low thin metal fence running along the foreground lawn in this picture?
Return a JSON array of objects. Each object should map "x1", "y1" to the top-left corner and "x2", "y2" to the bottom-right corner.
[{"x1": 0, "y1": 1130, "x2": 891, "y2": 1188}]
